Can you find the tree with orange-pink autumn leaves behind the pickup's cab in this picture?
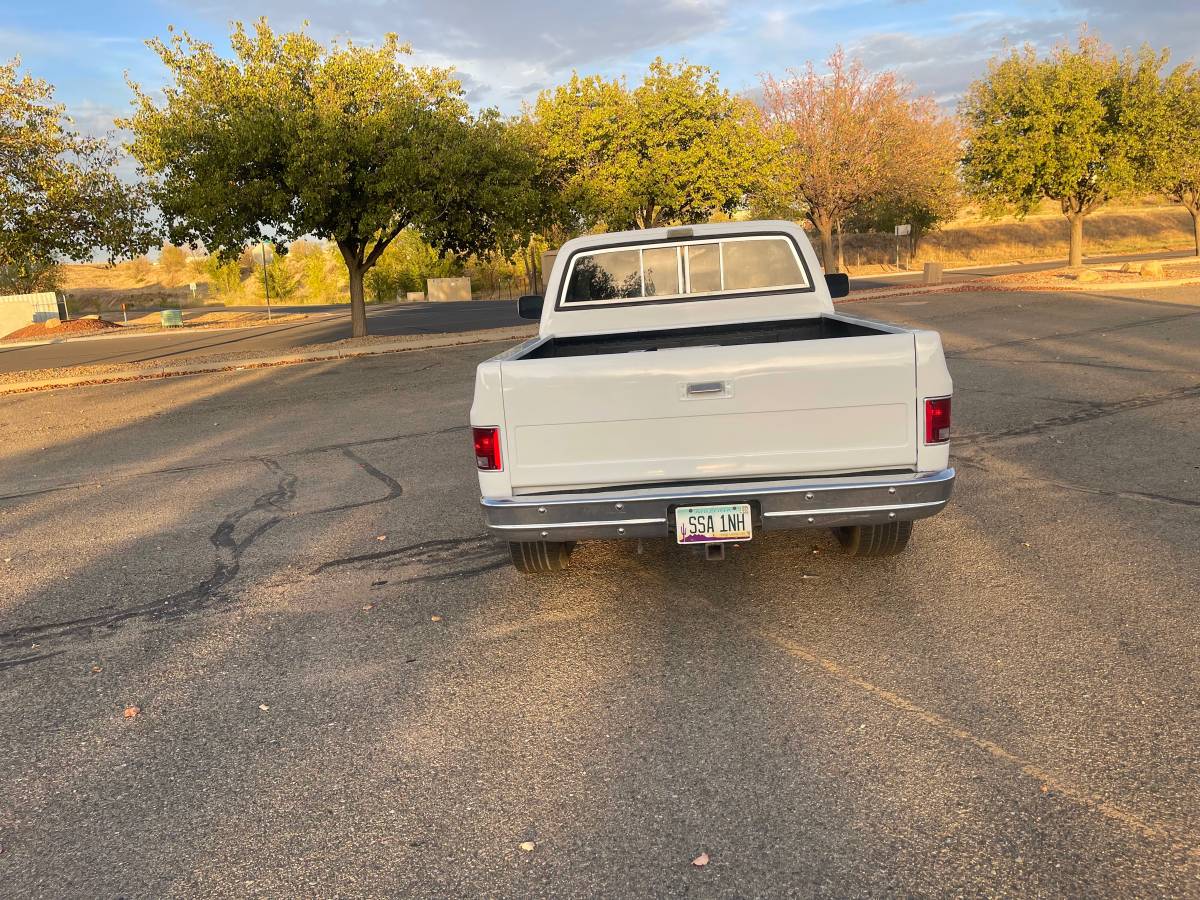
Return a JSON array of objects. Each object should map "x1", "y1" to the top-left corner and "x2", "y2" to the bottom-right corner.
[{"x1": 756, "y1": 49, "x2": 958, "y2": 271}]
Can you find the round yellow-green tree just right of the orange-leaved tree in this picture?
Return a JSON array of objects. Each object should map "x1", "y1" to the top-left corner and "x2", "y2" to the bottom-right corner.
[{"x1": 961, "y1": 32, "x2": 1166, "y2": 266}]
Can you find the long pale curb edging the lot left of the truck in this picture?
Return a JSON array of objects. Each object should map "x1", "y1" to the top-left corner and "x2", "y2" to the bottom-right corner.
[{"x1": 0, "y1": 325, "x2": 536, "y2": 395}]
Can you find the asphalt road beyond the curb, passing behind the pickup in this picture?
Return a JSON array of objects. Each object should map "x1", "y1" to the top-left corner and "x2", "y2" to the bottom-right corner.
[{"x1": 0, "y1": 247, "x2": 1186, "y2": 372}]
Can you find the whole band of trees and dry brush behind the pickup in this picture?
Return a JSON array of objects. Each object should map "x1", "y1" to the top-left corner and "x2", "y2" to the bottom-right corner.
[{"x1": 0, "y1": 19, "x2": 1200, "y2": 335}]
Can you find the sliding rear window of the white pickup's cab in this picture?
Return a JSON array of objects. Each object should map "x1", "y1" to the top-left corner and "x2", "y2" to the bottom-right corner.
[{"x1": 563, "y1": 235, "x2": 809, "y2": 305}]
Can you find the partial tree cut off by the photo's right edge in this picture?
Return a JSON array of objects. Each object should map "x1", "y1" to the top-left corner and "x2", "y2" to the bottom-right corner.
[{"x1": 1154, "y1": 65, "x2": 1200, "y2": 257}]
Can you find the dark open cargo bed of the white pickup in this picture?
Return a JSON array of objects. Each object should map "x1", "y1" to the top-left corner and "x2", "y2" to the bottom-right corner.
[{"x1": 515, "y1": 316, "x2": 892, "y2": 360}]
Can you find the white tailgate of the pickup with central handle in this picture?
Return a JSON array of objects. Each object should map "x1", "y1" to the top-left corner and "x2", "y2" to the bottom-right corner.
[{"x1": 502, "y1": 334, "x2": 917, "y2": 492}]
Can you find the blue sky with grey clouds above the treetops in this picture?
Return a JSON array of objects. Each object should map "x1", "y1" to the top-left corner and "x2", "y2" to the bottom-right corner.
[{"x1": 0, "y1": 0, "x2": 1200, "y2": 133}]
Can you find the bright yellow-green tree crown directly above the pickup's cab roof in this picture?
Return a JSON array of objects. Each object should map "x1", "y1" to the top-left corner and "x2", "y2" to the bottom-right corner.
[{"x1": 527, "y1": 59, "x2": 763, "y2": 228}]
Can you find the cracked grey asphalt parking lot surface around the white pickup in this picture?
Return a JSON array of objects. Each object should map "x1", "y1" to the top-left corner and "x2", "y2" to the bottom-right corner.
[{"x1": 0, "y1": 289, "x2": 1200, "y2": 898}]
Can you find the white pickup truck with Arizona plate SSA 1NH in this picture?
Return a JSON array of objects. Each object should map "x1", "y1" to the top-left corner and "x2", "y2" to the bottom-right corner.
[{"x1": 470, "y1": 222, "x2": 954, "y2": 572}]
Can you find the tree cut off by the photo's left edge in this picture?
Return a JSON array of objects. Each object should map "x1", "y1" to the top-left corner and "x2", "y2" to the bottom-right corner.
[{"x1": 0, "y1": 59, "x2": 152, "y2": 290}]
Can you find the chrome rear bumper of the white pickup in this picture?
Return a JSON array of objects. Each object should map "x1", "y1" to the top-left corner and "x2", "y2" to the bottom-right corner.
[{"x1": 480, "y1": 469, "x2": 954, "y2": 541}]
